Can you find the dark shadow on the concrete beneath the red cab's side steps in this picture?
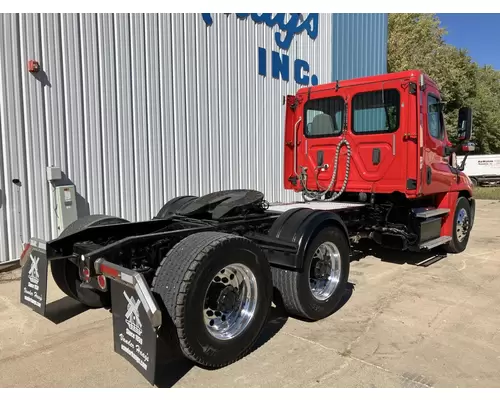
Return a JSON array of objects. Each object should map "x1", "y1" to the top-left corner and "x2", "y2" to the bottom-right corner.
[{"x1": 351, "y1": 242, "x2": 446, "y2": 268}]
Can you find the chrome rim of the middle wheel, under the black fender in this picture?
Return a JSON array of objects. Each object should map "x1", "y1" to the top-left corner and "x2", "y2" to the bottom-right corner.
[{"x1": 309, "y1": 242, "x2": 342, "y2": 301}]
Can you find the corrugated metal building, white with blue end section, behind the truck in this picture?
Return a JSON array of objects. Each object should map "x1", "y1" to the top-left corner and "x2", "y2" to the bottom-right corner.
[{"x1": 0, "y1": 14, "x2": 387, "y2": 262}]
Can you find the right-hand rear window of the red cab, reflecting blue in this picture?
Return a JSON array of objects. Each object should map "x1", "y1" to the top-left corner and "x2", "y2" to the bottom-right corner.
[{"x1": 352, "y1": 89, "x2": 400, "y2": 134}]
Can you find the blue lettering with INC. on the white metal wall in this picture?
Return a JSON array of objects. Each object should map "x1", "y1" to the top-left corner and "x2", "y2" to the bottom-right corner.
[{"x1": 202, "y1": 13, "x2": 319, "y2": 86}]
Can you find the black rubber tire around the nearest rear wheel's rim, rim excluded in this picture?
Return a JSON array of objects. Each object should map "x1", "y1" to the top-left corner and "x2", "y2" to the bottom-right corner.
[{"x1": 153, "y1": 232, "x2": 272, "y2": 368}]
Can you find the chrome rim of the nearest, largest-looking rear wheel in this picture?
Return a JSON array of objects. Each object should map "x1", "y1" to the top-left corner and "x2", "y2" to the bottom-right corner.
[{"x1": 203, "y1": 264, "x2": 258, "y2": 340}]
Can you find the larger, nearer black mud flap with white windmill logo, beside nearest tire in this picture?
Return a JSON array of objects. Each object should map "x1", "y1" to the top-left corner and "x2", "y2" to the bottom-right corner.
[{"x1": 111, "y1": 280, "x2": 157, "y2": 385}]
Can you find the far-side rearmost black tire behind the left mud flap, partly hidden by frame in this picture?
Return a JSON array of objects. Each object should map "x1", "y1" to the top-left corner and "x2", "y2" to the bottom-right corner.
[{"x1": 51, "y1": 215, "x2": 128, "y2": 308}]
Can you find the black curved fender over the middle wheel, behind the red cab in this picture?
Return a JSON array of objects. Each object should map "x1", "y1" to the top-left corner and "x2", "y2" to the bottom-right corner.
[{"x1": 269, "y1": 208, "x2": 349, "y2": 271}]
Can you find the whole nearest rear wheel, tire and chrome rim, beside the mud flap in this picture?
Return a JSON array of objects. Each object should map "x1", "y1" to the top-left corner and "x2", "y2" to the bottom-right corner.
[{"x1": 153, "y1": 232, "x2": 272, "y2": 368}]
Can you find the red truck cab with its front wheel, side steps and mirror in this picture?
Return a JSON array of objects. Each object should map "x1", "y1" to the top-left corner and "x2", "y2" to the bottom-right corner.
[{"x1": 284, "y1": 70, "x2": 475, "y2": 252}]
